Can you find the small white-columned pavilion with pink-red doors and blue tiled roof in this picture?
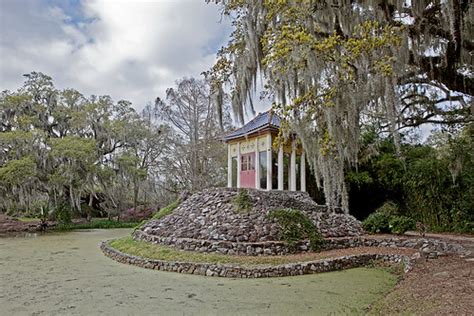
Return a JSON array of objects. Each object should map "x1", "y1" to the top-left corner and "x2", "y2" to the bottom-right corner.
[{"x1": 224, "y1": 110, "x2": 306, "y2": 191}]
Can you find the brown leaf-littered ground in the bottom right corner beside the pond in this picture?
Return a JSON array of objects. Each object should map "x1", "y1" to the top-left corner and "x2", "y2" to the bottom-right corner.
[{"x1": 371, "y1": 233, "x2": 474, "y2": 315}]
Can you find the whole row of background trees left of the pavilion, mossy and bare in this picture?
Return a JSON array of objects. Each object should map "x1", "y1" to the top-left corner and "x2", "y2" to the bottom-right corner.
[{"x1": 0, "y1": 72, "x2": 230, "y2": 218}]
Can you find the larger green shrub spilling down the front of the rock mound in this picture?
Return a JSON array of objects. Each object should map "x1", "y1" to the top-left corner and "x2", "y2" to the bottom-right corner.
[{"x1": 268, "y1": 209, "x2": 324, "y2": 251}]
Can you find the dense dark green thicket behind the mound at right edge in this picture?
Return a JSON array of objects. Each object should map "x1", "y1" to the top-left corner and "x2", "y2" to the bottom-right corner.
[{"x1": 347, "y1": 124, "x2": 474, "y2": 233}]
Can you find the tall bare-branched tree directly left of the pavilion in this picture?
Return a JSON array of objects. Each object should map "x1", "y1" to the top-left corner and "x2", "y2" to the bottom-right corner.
[{"x1": 155, "y1": 78, "x2": 232, "y2": 191}]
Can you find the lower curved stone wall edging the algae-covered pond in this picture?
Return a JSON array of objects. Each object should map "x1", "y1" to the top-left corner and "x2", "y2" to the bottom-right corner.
[{"x1": 100, "y1": 242, "x2": 414, "y2": 278}]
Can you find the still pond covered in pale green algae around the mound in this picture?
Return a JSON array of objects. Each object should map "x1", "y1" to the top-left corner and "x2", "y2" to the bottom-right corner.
[{"x1": 0, "y1": 229, "x2": 396, "y2": 316}]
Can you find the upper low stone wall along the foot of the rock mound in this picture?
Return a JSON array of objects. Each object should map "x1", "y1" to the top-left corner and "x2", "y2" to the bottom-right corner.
[{"x1": 133, "y1": 230, "x2": 465, "y2": 256}]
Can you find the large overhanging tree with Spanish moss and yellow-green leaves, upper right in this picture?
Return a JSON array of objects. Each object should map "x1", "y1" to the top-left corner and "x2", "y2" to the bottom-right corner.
[{"x1": 208, "y1": 0, "x2": 474, "y2": 210}]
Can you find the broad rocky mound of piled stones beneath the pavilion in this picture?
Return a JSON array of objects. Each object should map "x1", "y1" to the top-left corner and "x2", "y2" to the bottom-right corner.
[{"x1": 134, "y1": 188, "x2": 363, "y2": 249}]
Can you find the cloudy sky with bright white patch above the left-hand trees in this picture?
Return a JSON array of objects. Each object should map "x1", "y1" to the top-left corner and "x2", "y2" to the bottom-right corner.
[{"x1": 0, "y1": 0, "x2": 231, "y2": 109}]
